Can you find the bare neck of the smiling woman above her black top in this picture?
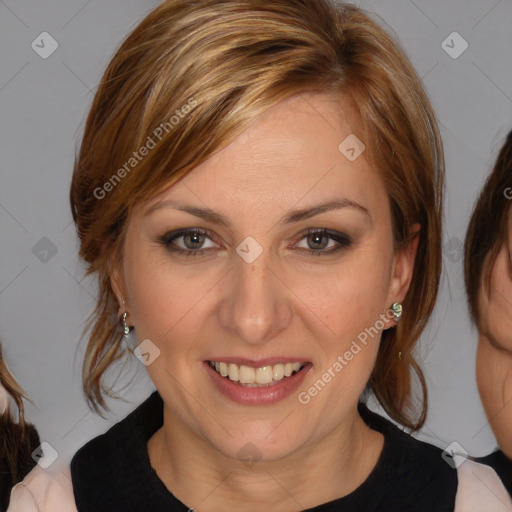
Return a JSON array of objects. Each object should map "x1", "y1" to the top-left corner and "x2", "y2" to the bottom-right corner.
[{"x1": 148, "y1": 406, "x2": 384, "y2": 512}]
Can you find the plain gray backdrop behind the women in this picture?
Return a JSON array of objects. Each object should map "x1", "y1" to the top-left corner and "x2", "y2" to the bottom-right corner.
[{"x1": 0, "y1": 0, "x2": 512, "y2": 457}]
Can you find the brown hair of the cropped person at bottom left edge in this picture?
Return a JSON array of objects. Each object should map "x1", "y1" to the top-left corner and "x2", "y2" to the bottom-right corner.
[{"x1": 0, "y1": 345, "x2": 40, "y2": 511}]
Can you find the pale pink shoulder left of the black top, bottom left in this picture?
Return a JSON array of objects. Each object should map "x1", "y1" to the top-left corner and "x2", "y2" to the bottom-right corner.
[{"x1": 7, "y1": 464, "x2": 77, "y2": 512}]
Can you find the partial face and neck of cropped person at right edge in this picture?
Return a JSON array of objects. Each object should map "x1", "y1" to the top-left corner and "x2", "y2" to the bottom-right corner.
[{"x1": 476, "y1": 209, "x2": 512, "y2": 459}]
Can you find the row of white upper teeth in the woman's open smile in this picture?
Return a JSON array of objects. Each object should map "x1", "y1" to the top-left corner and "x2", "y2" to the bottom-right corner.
[{"x1": 208, "y1": 361, "x2": 309, "y2": 387}]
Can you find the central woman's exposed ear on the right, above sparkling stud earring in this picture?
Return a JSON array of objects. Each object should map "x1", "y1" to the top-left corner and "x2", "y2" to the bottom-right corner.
[{"x1": 386, "y1": 224, "x2": 421, "y2": 327}]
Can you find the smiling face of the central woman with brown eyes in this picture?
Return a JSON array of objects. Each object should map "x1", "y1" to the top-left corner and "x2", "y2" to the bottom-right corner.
[{"x1": 114, "y1": 95, "x2": 416, "y2": 460}]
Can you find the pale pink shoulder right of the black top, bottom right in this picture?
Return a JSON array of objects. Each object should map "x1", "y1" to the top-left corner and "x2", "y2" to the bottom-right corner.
[{"x1": 455, "y1": 456, "x2": 512, "y2": 512}]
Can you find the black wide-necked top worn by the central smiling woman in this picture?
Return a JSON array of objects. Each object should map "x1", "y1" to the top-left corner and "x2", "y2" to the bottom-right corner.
[{"x1": 71, "y1": 391, "x2": 457, "y2": 512}]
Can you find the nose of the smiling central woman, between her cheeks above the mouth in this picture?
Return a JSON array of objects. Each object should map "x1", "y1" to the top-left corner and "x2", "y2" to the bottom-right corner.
[{"x1": 218, "y1": 247, "x2": 293, "y2": 345}]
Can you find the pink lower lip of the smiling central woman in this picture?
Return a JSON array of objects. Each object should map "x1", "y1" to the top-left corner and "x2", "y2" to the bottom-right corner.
[{"x1": 203, "y1": 361, "x2": 312, "y2": 405}]
